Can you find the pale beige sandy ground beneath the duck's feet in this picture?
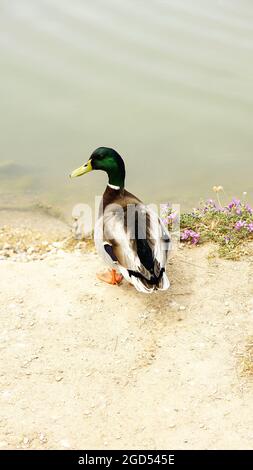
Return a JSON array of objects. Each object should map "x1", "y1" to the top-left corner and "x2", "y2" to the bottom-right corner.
[{"x1": 0, "y1": 213, "x2": 253, "y2": 449}]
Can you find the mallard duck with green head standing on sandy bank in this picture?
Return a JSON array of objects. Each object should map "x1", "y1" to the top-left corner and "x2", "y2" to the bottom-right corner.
[{"x1": 70, "y1": 147, "x2": 170, "y2": 293}]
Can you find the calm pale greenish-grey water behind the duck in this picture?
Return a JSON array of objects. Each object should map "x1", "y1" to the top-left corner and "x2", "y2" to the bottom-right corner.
[{"x1": 0, "y1": 0, "x2": 253, "y2": 215}]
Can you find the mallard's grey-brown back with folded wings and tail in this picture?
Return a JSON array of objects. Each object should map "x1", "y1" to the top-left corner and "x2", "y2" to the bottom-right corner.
[{"x1": 97, "y1": 198, "x2": 170, "y2": 292}]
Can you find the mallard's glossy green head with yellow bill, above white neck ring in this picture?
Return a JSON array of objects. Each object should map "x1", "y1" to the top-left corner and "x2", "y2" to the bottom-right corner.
[{"x1": 70, "y1": 147, "x2": 125, "y2": 188}]
